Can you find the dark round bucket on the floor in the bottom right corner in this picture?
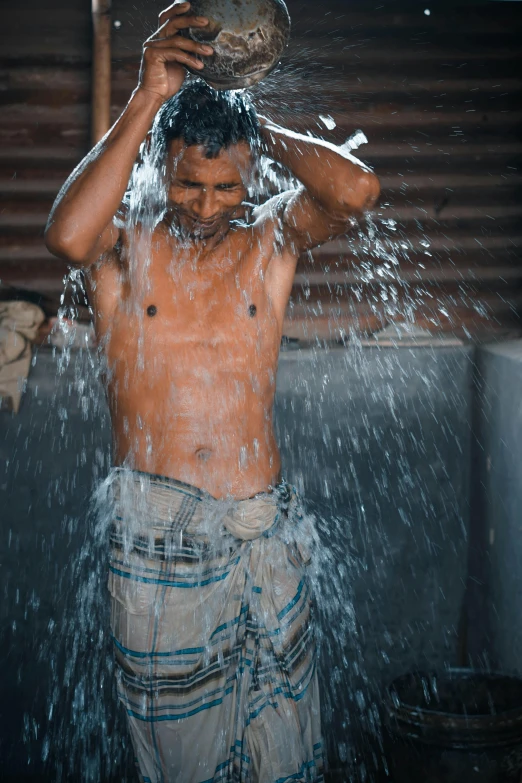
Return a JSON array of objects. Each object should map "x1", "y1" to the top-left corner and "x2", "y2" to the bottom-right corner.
[{"x1": 385, "y1": 669, "x2": 522, "y2": 783}]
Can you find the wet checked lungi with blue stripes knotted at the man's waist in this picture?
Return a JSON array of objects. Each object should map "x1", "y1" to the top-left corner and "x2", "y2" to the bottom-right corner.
[{"x1": 109, "y1": 469, "x2": 323, "y2": 783}]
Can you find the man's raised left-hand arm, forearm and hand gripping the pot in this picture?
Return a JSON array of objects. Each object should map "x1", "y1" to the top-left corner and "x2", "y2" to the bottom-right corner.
[{"x1": 45, "y1": 3, "x2": 212, "y2": 266}]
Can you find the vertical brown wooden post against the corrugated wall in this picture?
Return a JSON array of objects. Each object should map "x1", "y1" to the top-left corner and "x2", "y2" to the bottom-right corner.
[{"x1": 91, "y1": 0, "x2": 111, "y2": 145}]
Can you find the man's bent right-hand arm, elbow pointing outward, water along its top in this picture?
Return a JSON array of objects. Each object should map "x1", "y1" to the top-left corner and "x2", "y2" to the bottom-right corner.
[{"x1": 260, "y1": 118, "x2": 380, "y2": 253}]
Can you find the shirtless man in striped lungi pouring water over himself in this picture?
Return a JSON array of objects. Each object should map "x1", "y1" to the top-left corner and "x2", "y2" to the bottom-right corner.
[{"x1": 46, "y1": 3, "x2": 379, "y2": 783}]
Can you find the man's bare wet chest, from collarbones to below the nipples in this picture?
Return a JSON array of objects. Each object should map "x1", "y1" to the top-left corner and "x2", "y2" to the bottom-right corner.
[{"x1": 100, "y1": 231, "x2": 281, "y2": 374}]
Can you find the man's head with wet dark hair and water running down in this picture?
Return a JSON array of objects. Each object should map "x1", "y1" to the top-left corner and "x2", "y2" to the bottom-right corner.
[{"x1": 155, "y1": 81, "x2": 259, "y2": 239}]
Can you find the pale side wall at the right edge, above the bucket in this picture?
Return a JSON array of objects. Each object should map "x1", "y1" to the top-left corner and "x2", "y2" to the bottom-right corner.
[{"x1": 470, "y1": 340, "x2": 522, "y2": 674}]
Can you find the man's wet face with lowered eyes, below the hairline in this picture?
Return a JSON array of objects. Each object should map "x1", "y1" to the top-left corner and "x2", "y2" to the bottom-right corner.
[{"x1": 168, "y1": 139, "x2": 253, "y2": 240}]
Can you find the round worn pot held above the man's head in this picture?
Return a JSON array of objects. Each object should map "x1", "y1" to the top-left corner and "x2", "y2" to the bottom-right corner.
[{"x1": 182, "y1": 0, "x2": 290, "y2": 90}]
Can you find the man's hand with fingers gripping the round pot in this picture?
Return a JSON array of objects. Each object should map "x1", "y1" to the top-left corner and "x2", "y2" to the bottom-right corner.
[{"x1": 138, "y1": 2, "x2": 214, "y2": 102}]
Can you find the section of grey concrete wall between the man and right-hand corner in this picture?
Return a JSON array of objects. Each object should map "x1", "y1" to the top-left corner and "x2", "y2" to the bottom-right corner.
[{"x1": 276, "y1": 346, "x2": 473, "y2": 780}]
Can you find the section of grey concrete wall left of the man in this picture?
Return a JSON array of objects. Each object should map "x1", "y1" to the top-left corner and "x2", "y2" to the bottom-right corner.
[{"x1": 0, "y1": 351, "x2": 116, "y2": 783}]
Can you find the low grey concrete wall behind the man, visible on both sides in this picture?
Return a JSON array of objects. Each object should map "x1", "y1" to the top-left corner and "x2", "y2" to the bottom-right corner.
[{"x1": 0, "y1": 347, "x2": 471, "y2": 783}]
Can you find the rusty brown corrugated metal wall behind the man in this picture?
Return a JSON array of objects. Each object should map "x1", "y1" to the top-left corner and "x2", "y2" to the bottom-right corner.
[{"x1": 0, "y1": 0, "x2": 522, "y2": 338}]
